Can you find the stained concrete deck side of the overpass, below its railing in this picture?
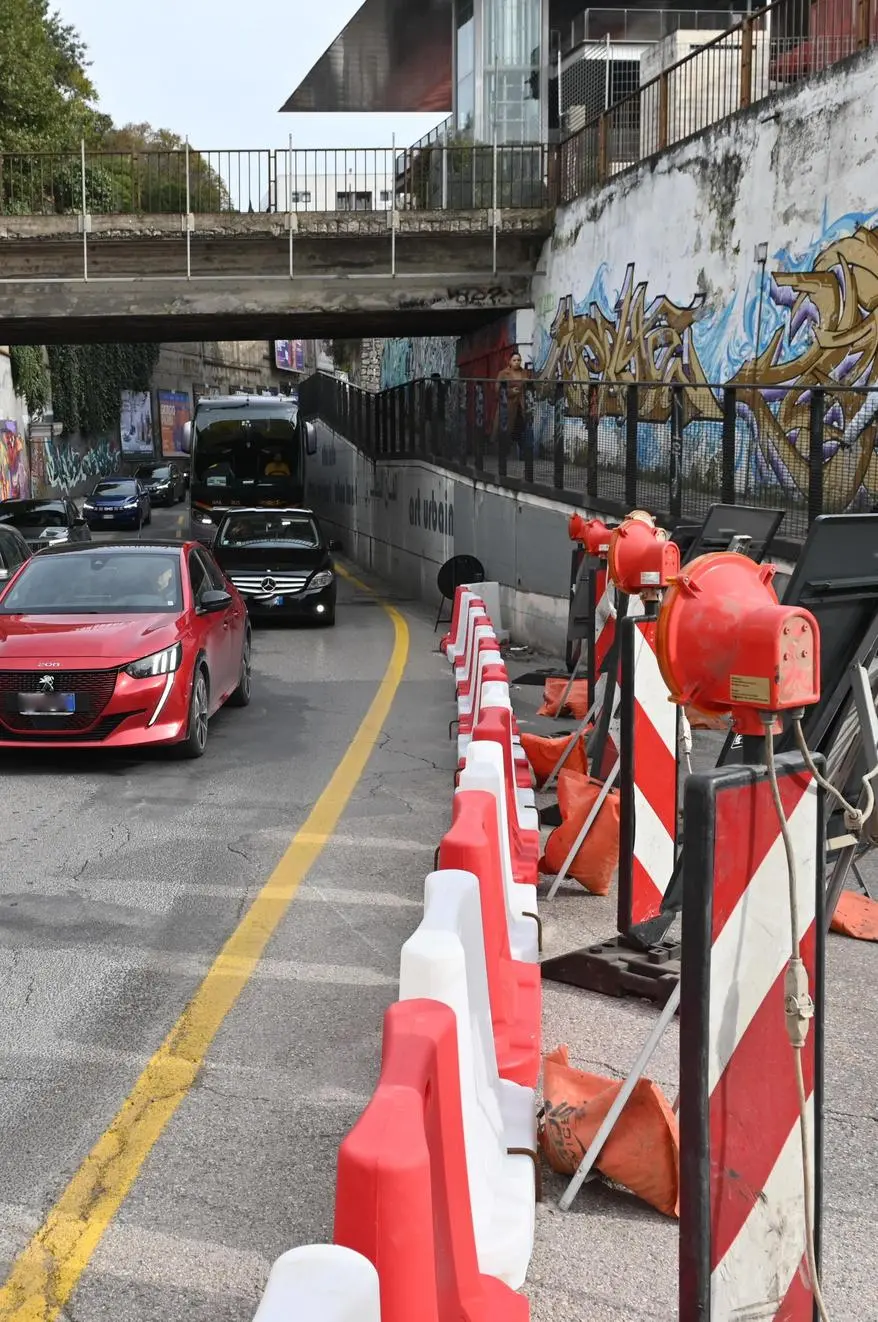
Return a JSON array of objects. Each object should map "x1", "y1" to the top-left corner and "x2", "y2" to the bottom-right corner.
[{"x1": 0, "y1": 210, "x2": 551, "y2": 344}]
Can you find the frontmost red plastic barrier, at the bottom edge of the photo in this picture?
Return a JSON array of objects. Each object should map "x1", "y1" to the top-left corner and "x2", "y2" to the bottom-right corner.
[{"x1": 335, "y1": 1001, "x2": 530, "y2": 1322}]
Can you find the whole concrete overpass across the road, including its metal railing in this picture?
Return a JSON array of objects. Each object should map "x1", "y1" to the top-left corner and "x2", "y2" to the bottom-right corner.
[{"x1": 0, "y1": 145, "x2": 554, "y2": 344}]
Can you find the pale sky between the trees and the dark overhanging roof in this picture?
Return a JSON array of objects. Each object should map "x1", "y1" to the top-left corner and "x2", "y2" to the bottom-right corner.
[{"x1": 54, "y1": 0, "x2": 444, "y2": 151}]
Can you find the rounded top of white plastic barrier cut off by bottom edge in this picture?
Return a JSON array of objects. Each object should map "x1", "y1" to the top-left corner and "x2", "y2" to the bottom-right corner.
[{"x1": 253, "y1": 1244, "x2": 381, "y2": 1322}]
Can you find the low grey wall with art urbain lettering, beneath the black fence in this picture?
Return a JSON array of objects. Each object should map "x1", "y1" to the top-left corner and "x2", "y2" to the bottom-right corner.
[{"x1": 307, "y1": 422, "x2": 571, "y2": 652}]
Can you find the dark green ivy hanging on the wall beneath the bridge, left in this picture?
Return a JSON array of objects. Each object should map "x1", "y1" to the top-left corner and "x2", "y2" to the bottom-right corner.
[{"x1": 49, "y1": 344, "x2": 159, "y2": 436}]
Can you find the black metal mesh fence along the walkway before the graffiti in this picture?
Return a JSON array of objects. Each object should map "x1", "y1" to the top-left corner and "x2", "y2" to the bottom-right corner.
[{"x1": 301, "y1": 375, "x2": 878, "y2": 539}]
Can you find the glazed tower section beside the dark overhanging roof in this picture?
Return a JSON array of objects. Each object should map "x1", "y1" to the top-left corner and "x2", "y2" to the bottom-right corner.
[{"x1": 477, "y1": 0, "x2": 546, "y2": 143}]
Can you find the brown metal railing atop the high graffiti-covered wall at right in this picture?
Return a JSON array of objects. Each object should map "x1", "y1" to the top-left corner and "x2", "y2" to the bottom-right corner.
[{"x1": 559, "y1": 0, "x2": 878, "y2": 202}]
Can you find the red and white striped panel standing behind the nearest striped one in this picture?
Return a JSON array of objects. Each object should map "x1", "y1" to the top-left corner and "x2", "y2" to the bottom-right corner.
[{"x1": 616, "y1": 611, "x2": 681, "y2": 936}]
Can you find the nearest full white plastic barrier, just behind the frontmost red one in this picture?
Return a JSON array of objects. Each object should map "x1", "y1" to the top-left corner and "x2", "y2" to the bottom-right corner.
[{"x1": 399, "y1": 870, "x2": 537, "y2": 1284}]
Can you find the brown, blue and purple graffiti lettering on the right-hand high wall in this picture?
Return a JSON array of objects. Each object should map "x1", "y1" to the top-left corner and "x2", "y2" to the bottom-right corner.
[{"x1": 536, "y1": 213, "x2": 878, "y2": 510}]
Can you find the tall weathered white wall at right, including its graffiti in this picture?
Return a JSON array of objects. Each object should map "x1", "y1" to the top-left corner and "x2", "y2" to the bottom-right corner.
[{"x1": 533, "y1": 49, "x2": 878, "y2": 509}]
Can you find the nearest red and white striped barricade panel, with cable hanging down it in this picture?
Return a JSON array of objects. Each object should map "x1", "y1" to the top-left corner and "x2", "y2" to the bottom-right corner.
[{"x1": 680, "y1": 754, "x2": 825, "y2": 1322}]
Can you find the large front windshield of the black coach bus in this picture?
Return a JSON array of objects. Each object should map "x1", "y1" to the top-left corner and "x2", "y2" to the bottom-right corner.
[{"x1": 192, "y1": 408, "x2": 301, "y2": 496}]
